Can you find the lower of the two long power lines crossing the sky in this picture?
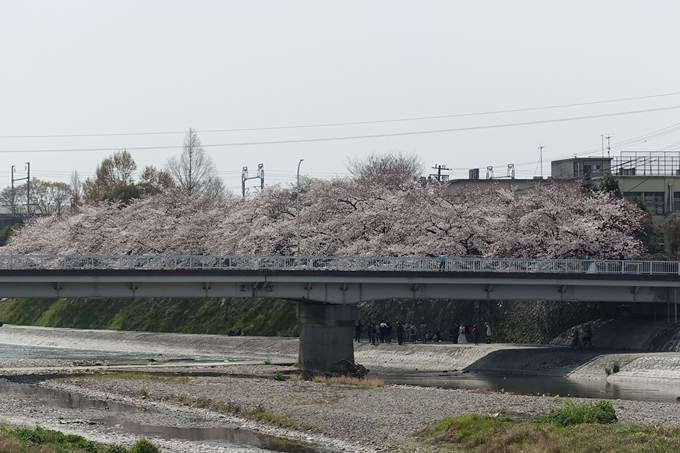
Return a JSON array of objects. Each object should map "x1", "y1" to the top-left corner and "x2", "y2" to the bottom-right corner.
[{"x1": 0, "y1": 105, "x2": 680, "y2": 153}]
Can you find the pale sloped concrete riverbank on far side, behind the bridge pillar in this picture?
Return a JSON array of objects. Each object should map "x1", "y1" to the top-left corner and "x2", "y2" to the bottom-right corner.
[{"x1": 0, "y1": 325, "x2": 680, "y2": 382}]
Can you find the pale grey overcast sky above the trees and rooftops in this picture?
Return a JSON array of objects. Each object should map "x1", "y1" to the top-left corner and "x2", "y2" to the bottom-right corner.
[{"x1": 0, "y1": 0, "x2": 680, "y2": 193}]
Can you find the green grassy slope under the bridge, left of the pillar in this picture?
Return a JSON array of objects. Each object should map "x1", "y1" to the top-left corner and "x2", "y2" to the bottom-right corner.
[{"x1": 0, "y1": 299, "x2": 299, "y2": 337}]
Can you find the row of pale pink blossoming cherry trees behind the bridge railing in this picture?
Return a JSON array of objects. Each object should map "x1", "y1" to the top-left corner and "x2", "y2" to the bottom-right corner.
[{"x1": 2, "y1": 178, "x2": 642, "y2": 259}]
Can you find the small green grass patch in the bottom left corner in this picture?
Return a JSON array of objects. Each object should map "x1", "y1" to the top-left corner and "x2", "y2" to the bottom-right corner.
[{"x1": 0, "y1": 425, "x2": 159, "y2": 453}]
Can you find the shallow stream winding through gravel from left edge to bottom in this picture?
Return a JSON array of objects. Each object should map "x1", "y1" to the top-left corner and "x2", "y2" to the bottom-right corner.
[{"x1": 0, "y1": 381, "x2": 338, "y2": 453}]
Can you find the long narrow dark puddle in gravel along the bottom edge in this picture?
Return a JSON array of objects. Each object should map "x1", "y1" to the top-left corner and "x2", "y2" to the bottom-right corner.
[{"x1": 93, "y1": 415, "x2": 337, "y2": 453}]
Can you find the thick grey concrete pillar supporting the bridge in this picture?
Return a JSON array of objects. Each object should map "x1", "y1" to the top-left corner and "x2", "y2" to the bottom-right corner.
[{"x1": 298, "y1": 302, "x2": 358, "y2": 375}]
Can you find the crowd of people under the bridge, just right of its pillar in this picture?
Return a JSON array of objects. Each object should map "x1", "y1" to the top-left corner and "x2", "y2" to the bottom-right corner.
[{"x1": 354, "y1": 320, "x2": 491, "y2": 345}]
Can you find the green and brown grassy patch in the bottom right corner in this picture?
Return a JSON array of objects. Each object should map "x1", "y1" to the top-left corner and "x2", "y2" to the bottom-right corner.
[{"x1": 419, "y1": 401, "x2": 680, "y2": 453}]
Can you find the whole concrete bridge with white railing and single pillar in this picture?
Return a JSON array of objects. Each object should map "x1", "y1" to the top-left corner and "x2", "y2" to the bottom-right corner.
[{"x1": 0, "y1": 255, "x2": 680, "y2": 373}]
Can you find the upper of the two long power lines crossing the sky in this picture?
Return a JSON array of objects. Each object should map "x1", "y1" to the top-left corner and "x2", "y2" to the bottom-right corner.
[{"x1": 0, "y1": 92, "x2": 680, "y2": 138}]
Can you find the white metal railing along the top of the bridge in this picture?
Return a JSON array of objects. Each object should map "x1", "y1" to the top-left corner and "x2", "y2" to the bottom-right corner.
[{"x1": 0, "y1": 255, "x2": 680, "y2": 275}]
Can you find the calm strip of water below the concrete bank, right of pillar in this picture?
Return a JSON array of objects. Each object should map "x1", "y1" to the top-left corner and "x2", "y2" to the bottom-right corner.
[{"x1": 371, "y1": 368, "x2": 680, "y2": 402}]
